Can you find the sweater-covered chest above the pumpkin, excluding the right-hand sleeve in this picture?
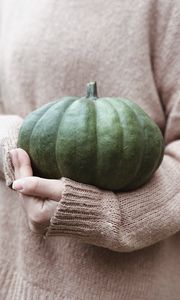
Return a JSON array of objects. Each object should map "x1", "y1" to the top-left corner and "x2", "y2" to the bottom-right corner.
[{"x1": 0, "y1": 0, "x2": 164, "y2": 128}]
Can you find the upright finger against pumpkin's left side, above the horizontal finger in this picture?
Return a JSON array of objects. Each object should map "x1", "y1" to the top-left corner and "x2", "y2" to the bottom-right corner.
[{"x1": 10, "y1": 148, "x2": 33, "y2": 179}]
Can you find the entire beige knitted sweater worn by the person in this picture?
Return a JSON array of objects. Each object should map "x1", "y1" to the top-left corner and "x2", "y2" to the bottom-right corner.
[{"x1": 0, "y1": 0, "x2": 180, "y2": 300}]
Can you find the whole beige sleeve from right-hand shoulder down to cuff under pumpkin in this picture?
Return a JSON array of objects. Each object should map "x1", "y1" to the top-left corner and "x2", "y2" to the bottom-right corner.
[{"x1": 46, "y1": 1, "x2": 180, "y2": 252}]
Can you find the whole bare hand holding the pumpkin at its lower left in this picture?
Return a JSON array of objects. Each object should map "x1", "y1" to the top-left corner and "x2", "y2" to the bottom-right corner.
[{"x1": 10, "y1": 148, "x2": 63, "y2": 233}]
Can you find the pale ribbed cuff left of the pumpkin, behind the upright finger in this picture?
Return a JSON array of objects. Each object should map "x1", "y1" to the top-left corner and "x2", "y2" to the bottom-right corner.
[{"x1": 2, "y1": 118, "x2": 23, "y2": 187}]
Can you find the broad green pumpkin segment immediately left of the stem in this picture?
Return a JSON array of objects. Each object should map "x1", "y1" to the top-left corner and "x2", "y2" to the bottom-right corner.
[{"x1": 58, "y1": 97, "x2": 96, "y2": 184}]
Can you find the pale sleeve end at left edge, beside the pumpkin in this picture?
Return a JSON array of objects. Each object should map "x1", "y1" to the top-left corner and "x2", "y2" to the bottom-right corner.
[{"x1": 0, "y1": 115, "x2": 23, "y2": 186}]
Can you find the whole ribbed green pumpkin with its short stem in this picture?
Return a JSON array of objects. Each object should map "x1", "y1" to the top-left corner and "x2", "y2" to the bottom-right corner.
[{"x1": 18, "y1": 82, "x2": 164, "y2": 191}]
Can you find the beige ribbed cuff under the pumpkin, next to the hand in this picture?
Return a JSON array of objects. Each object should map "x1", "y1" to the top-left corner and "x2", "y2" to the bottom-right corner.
[{"x1": 45, "y1": 178, "x2": 102, "y2": 240}]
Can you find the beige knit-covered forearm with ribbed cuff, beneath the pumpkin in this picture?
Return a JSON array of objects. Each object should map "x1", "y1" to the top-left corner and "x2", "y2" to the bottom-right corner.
[{"x1": 47, "y1": 142, "x2": 180, "y2": 252}]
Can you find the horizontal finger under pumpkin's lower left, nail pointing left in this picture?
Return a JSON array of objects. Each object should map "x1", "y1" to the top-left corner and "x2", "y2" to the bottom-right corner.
[{"x1": 12, "y1": 176, "x2": 63, "y2": 201}]
